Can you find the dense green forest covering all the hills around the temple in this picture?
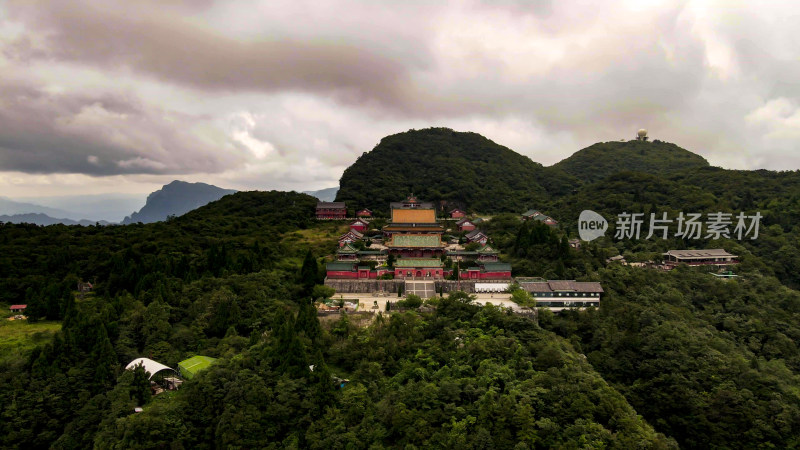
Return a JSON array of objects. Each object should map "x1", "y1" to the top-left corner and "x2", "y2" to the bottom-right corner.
[{"x1": 0, "y1": 129, "x2": 800, "y2": 449}]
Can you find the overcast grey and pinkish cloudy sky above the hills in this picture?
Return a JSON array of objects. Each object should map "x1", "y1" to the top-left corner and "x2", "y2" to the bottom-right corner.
[{"x1": 0, "y1": 0, "x2": 800, "y2": 198}]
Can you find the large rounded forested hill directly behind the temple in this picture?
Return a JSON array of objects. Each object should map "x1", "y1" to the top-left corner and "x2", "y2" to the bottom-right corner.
[{"x1": 336, "y1": 128, "x2": 572, "y2": 213}]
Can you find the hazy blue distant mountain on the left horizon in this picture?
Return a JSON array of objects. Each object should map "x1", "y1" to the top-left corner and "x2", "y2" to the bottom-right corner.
[{"x1": 122, "y1": 180, "x2": 236, "y2": 225}]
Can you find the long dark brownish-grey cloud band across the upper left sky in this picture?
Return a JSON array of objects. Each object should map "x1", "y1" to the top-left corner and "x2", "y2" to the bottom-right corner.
[{"x1": 9, "y1": 1, "x2": 432, "y2": 108}]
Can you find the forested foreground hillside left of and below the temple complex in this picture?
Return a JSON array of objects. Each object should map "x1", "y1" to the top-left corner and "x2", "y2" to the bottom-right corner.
[{"x1": 0, "y1": 192, "x2": 671, "y2": 448}]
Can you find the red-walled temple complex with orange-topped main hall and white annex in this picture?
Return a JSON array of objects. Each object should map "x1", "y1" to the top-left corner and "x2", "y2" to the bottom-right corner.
[{"x1": 318, "y1": 195, "x2": 603, "y2": 311}]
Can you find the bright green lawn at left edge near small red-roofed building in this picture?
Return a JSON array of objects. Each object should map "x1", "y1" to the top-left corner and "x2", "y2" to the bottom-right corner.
[{"x1": 0, "y1": 305, "x2": 61, "y2": 361}]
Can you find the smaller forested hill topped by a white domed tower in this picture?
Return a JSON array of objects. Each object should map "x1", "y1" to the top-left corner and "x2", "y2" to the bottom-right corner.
[{"x1": 552, "y1": 140, "x2": 708, "y2": 183}]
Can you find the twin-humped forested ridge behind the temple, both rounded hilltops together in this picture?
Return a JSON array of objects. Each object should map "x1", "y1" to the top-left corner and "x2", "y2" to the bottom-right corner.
[{"x1": 336, "y1": 128, "x2": 708, "y2": 213}]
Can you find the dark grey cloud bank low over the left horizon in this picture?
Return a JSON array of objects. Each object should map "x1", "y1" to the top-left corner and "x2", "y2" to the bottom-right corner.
[{"x1": 0, "y1": 82, "x2": 241, "y2": 175}]
